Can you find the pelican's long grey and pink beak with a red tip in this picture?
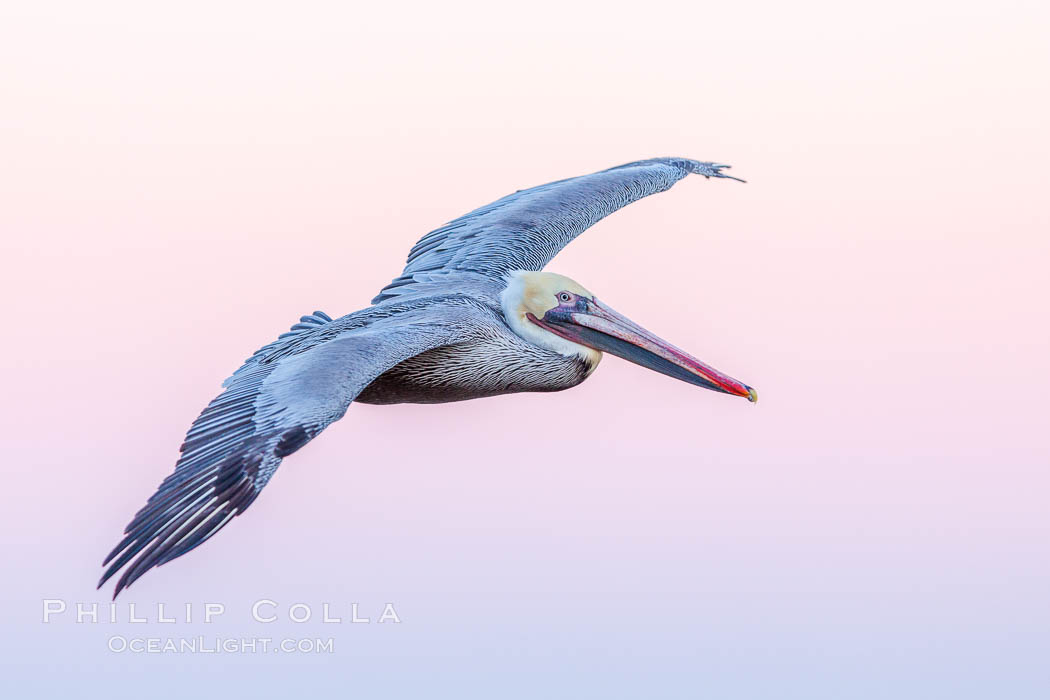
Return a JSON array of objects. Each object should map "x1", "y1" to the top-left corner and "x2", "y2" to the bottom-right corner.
[{"x1": 529, "y1": 299, "x2": 758, "y2": 403}]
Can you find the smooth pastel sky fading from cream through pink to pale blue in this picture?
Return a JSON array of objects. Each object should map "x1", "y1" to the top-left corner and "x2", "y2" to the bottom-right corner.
[{"x1": 0, "y1": 0, "x2": 1050, "y2": 700}]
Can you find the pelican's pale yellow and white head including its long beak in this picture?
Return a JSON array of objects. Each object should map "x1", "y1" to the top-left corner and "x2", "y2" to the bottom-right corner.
[{"x1": 501, "y1": 272, "x2": 758, "y2": 402}]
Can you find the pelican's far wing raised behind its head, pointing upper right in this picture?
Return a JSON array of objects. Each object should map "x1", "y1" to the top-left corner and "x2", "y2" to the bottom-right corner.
[{"x1": 372, "y1": 157, "x2": 743, "y2": 303}]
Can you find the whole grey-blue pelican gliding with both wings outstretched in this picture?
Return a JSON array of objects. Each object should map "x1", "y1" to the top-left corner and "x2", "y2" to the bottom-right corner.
[{"x1": 99, "y1": 157, "x2": 757, "y2": 598}]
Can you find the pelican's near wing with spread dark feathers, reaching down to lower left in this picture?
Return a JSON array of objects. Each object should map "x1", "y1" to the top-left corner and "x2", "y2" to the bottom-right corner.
[{"x1": 99, "y1": 297, "x2": 480, "y2": 598}]
